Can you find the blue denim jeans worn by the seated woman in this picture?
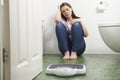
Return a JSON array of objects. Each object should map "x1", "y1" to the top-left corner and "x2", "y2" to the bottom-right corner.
[{"x1": 56, "y1": 22, "x2": 86, "y2": 56}]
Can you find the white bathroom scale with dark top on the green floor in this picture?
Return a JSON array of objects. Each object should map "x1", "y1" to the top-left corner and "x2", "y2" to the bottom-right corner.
[{"x1": 46, "y1": 64, "x2": 86, "y2": 77}]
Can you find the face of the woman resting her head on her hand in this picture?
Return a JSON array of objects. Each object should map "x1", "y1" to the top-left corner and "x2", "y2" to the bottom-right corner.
[{"x1": 61, "y1": 5, "x2": 72, "y2": 19}]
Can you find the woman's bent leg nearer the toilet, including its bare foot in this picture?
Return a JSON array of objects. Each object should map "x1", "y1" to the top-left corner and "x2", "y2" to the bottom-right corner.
[{"x1": 71, "y1": 22, "x2": 85, "y2": 59}]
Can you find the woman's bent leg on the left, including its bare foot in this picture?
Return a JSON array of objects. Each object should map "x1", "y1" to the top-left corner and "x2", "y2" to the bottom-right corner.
[{"x1": 56, "y1": 22, "x2": 70, "y2": 59}]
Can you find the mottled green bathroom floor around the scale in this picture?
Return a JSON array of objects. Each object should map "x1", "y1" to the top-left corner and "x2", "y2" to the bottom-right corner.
[{"x1": 34, "y1": 54, "x2": 120, "y2": 80}]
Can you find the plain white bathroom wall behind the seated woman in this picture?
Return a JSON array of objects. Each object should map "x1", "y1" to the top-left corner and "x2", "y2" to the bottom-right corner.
[{"x1": 42, "y1": 0, "x2": 120, "y2": 54}]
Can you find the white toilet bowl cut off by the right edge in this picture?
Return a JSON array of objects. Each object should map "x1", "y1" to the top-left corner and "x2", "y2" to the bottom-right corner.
[{"x1": 99, "y1": 24, "x2": 120, "y2": 52}]
